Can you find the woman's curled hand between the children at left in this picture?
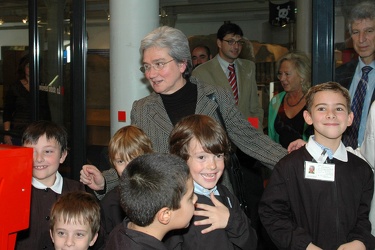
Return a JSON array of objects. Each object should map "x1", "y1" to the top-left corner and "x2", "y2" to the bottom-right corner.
[{"x1": 79, "y1": 165, "x2": 105, "y2": 191}]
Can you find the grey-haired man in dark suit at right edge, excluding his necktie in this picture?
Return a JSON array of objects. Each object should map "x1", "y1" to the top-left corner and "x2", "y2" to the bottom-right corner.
[{"x1": 335, "y1": 1, "x2": 375, "y2": 147}]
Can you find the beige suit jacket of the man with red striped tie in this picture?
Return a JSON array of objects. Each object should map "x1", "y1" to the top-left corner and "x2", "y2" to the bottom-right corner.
[{"x1": 192, "y1": 55, "x2": 264, "y2": 130}]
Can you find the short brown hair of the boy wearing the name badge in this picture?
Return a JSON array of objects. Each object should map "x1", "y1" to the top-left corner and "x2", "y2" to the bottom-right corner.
[{"x1": 306, "y1": 82, "x2": 351, "y2": 113}]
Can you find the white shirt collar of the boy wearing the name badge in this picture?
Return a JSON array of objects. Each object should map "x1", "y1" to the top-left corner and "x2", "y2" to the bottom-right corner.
[{"x1": 306, "y1": 135, "x2": 348, "y2": 163}]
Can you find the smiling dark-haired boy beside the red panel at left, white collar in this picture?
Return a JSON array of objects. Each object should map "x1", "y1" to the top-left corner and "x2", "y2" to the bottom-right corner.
[{"x1": 16, "y1": 121, "x2": 85, "y2": 250}]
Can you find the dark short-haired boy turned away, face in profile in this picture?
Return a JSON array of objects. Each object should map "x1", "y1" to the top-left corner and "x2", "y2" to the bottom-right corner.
[{"x1": 106, "y1": 153, "x2": 197, "y2": 250}]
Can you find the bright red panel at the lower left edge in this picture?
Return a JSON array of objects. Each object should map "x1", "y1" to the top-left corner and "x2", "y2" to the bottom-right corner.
[{"x1": 0, "y1": 145, "x2": 33, "y2": 249}]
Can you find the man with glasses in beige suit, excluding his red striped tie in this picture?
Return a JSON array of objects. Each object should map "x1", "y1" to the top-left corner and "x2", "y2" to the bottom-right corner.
[{"x1": 192, "y1": 23, "x2": 263, "y2": 130}]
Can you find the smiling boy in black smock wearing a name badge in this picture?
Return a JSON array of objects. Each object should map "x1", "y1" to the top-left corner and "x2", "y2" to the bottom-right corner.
[{"x1": 259, "y1": 82, "x2": 375, "y2": 250}]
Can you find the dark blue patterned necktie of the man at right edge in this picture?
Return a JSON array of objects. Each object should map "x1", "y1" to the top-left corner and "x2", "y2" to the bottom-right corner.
[{"x1": 344, "y1": 66, "x2": 372, "y2": 149}]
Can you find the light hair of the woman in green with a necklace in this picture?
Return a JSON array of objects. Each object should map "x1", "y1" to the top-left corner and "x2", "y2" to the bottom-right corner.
[{"x1": 276, "y1": 51, "x2": 311, "y2": 94}]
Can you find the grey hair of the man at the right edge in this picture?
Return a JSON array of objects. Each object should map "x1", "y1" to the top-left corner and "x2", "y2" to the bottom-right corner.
[{"x1": 348, "y1": 1, "x2": 375, "y2": 34}]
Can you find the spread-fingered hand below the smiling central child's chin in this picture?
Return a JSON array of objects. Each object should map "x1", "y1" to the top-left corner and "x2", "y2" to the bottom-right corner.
[{"x1": 194, "y1": 192, "x2": 230, "y2": 234}]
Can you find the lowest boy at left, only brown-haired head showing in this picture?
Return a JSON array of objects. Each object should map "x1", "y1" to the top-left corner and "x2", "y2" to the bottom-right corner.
[{"x1": 50, "y1": 191, "x2": 100, "y2": 250}]
